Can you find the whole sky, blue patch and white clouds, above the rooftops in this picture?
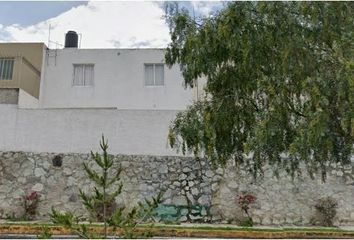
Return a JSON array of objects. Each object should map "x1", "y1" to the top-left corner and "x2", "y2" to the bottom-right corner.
[{"x1": 0, "y1": 1, "x2": 222, "y2": 48}]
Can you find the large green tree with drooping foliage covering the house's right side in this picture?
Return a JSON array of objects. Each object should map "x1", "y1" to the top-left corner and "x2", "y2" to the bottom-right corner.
[{"x1": 165, "y1": 2, "x2": 354, "y2": 177}]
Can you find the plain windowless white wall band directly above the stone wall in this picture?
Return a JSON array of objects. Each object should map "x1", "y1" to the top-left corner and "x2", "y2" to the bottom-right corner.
[{"x1": 0, "y1": 104, "x2": 183, "y2": 156}]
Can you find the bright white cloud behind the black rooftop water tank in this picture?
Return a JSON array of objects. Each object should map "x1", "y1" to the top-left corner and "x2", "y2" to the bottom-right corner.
[{"x1": 0, "y1": 1, "x2": 221, "y2": 48}]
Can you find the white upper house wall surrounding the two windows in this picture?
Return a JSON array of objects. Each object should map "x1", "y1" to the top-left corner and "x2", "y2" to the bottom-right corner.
[{"x1": 40, "y1": 49, "x2": 193, "y2": 110}]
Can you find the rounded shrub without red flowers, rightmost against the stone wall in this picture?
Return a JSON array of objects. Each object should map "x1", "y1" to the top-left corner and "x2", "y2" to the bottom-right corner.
[{"x1": 311, "y1": 197, "x2": 338, "y2": 227}]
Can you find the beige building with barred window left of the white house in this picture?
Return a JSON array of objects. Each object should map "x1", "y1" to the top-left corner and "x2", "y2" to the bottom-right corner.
[{"x1": 0, "y1": 43, "x2": 47, "y2": 104}]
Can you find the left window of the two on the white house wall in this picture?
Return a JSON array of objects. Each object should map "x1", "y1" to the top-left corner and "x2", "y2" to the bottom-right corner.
[{"x1": 73, "y1": 64, "x2": 94, "y2": 86}]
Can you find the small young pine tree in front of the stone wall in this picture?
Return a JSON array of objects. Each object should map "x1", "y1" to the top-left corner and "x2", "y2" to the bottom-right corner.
[{"x1": 50, "y1": 136, "x2": 163, "y2": 238}]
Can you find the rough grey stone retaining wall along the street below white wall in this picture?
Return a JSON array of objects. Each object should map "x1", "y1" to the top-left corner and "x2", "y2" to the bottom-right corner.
[{"x1": 0, "y1": 152, "x2": 354, "y2": 225}]
